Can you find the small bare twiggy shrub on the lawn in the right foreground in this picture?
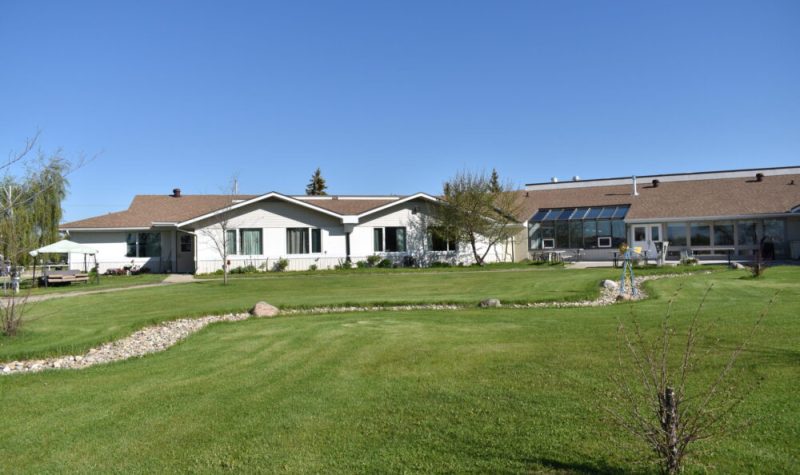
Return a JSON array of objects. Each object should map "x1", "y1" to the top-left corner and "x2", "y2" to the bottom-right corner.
[{"x1": 605, "y1": 285, "x2": 777, "y2": 474}]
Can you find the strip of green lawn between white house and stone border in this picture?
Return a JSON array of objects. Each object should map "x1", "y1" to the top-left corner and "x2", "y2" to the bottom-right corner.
[{"x1": 0, "y1": 267, "x2": 610, "y2": 361}]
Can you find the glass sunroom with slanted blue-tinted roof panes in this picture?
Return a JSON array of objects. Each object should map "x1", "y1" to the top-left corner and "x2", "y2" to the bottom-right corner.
[{"x1": 528, "y1": 205, "x2": 630, "y2": 255}]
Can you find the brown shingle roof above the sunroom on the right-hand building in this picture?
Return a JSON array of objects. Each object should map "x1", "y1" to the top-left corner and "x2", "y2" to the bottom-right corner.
[{"x1": 519, "y1": 175, "x2": 800, "y2": 220}]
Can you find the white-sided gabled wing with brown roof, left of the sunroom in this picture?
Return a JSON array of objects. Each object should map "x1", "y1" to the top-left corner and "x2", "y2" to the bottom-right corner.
[{"x1": 60, "y1": 189, "x2": 516, "y2": 273}]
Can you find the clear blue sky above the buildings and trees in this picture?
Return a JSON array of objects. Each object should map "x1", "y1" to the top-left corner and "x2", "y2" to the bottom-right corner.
[{"x1": 0, "y1": 0, "x2": 800, "y2": 220}]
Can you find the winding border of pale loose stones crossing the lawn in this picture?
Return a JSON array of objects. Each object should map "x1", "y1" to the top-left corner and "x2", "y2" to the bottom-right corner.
[{"x1": 0, "y1": 272, "x2": 708, "y2": 375}]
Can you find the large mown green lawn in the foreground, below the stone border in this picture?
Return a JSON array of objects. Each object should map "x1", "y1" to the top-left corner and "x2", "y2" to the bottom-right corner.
[{"x1": 0, "y1": 268, "x2": 800, "y2": 473}]
